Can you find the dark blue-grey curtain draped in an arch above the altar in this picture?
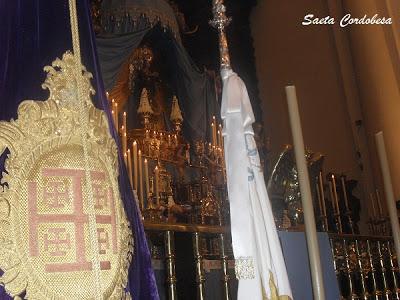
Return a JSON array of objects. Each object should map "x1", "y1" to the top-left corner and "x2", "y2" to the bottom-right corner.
[{"x1": 96, "y1": 22, "x2": 219, "y2": 140}]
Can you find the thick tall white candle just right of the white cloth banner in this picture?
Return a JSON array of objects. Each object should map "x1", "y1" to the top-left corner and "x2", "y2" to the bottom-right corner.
[{"x1": 286, "y1": 86, "x2": 325, "y2": 300}]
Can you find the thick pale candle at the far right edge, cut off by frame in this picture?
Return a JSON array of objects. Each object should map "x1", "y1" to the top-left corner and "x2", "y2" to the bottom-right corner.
[{"x1": 375, "y1": 131, "x2": 400, "y2": 257}]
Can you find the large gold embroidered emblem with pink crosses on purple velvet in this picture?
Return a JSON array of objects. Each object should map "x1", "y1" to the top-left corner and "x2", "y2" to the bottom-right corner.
[{"x1": 0, "y1": 52, "x2": 133, "y2": 299}]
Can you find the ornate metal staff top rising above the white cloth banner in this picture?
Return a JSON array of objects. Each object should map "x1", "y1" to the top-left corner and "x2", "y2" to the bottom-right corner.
[{"x1": 210, "y1": 0, "x2": 232, "y2": 69}]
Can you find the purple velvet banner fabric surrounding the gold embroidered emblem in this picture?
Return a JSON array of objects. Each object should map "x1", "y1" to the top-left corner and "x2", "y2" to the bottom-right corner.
[{"x1": 0, "y1": 0, "x2": 159, "y2": 299}]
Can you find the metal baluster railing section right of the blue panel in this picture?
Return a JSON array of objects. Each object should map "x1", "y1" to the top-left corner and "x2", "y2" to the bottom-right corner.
[{"x1": 329, "y1": 234, "x2": 400, "y2": 300}]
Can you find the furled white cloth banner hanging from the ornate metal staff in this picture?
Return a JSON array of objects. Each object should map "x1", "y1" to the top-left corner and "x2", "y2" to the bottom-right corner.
[{"x1": 221, "y1": 70, "x2": 293, "y2": 300}]
